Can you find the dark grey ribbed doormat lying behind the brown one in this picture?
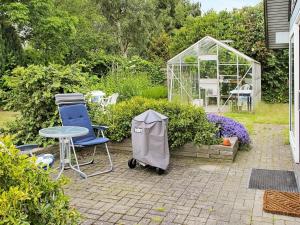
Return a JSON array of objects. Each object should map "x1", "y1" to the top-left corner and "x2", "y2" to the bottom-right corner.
[{"x1": 249, "y1": 169, "x2": 298, "y2": 192}]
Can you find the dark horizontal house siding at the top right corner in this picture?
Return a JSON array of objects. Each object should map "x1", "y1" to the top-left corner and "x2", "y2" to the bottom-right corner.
[{"x1": 265, "y1": 0, "x2": 290, "y2": 49}]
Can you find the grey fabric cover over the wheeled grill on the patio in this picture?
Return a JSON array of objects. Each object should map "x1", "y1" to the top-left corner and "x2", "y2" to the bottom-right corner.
[{"x1": 131, "y1": 110, "x2": 170, "y2": 170}]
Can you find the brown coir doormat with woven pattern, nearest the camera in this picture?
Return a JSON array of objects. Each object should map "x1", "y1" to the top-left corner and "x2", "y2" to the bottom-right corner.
[{"x1": 263, "y1": 190, "x2": 300, "y2": 217}]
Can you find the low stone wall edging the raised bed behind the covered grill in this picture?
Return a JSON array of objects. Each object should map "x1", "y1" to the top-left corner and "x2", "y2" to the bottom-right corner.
[{"x1": 108, "y1": 137, "x2": 239, "y2": 161}]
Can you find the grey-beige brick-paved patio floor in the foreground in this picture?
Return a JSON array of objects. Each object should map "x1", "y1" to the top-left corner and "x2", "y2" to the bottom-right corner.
[{"x1": 65, "y1": 125, "x2": 300, "y2": 225}]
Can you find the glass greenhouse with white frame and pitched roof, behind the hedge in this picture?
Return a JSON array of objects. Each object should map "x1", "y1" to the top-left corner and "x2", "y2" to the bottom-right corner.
[{"x1": 167, "y1": 36, "x2": 261, "y2": 112}]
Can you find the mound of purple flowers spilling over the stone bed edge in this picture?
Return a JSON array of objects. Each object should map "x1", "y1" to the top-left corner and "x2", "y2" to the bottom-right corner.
[{"x1": 207, "y1": 113, "x2": 250, "y2": 145}]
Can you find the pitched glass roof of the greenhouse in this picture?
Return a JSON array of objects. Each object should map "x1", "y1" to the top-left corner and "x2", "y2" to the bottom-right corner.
[{"x1": 168, "y1": 36, "x2": 259, "y2": 64}]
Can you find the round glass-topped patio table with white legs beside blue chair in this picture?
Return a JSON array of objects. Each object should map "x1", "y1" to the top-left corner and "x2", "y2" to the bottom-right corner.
[{"x1": 39, "y1": 126, "x2": 89, "y2": 179}]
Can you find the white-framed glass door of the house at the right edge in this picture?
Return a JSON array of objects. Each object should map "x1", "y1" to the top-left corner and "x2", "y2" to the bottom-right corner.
[{"x1": 289, "y1": 26, "x2": 300, "y2": 163}]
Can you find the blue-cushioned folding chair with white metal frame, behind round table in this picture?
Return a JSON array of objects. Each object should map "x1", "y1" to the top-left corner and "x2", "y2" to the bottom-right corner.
[{"x1": 55, "y1": 93, "x2": 113, "y2": 177}]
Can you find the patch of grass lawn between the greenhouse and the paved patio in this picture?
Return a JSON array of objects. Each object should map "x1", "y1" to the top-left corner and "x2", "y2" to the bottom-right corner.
[{"x1": 224, "y1": 102, "x2": 289, "y2": 144}]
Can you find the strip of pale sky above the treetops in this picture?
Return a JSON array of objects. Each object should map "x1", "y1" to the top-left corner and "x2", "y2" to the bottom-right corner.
[{"x1": 193, "y1": 0, "x2": 261, "y2": 12}]
